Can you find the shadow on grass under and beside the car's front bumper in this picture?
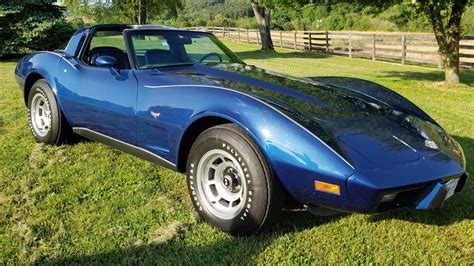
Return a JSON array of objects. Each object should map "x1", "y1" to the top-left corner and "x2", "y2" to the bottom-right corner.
[{"x1": 369, "y1": 136, "x2": 474, "y2": 226}]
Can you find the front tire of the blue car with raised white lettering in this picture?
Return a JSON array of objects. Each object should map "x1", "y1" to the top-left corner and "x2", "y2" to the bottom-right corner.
[{"x1": 187, "y1": 124, "x2": 285, "y2": 235}]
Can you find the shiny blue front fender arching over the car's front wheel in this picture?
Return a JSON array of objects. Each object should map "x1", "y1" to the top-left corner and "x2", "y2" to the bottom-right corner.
[{"x1": 170, "y1": 87, "x2": 354, "y2": 209}]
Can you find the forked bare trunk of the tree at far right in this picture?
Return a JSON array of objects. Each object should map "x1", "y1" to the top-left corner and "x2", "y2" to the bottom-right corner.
[{"x1": 428, "y1": 0, "x2": 468, "y2": 84}]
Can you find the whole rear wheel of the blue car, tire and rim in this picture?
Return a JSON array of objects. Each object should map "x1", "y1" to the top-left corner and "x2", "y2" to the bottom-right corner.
[{"x1": 27, "y1": 79, "x2": 73, "y2": 145}]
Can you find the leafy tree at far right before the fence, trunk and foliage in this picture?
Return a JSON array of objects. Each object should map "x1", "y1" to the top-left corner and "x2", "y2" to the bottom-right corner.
[{"x1": 412, "y1": 0, "x2": 470, "y2": 83}]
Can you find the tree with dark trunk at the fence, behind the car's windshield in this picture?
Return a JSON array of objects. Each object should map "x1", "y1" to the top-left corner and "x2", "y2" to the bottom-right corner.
[{"x1": 249, "y1": 0, "x2": 311, "y2": 50}]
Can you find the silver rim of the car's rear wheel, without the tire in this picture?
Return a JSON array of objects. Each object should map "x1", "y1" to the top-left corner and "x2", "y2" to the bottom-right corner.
[{"x1": 30, "y1": 93, "x2": 51, "y2": 137}]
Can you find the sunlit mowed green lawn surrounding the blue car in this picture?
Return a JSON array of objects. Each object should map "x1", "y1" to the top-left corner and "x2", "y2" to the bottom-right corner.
[{"x1": 0, "y1": 42, "x2": 474, "y2": 264}]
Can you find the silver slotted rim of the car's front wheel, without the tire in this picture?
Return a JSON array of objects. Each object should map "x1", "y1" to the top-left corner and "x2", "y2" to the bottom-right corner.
[{"x1": 196, "y1": 149, "x2": 247, "y2": 219}]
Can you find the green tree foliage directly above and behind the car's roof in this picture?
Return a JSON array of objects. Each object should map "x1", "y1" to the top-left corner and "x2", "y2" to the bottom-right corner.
[{"x1": 64, "y1": 0, "x2": 184, "y2": 24}]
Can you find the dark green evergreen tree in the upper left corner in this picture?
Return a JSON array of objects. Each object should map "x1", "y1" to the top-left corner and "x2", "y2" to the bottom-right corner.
[{"x1": 0, "y1": 0, "x2": 74, "y2": 57}]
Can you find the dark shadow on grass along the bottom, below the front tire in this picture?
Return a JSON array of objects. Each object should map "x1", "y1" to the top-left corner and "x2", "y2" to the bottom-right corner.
[{"x1": 43, "y1": 210, "x2": 347, "y2": 265}]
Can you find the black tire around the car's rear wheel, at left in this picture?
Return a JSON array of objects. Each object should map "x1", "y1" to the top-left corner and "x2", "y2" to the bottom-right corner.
[{"x1": 27, "y1": 79, "x2": 74, "y2": 145}]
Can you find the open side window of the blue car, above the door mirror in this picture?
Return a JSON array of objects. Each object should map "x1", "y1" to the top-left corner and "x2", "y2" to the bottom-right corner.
[{"x1": 84, "y1": 31, "x2": 130, "y2": 69}]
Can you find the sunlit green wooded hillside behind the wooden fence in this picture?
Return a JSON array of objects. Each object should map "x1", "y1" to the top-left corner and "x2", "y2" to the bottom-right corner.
[{"x1": 151, "y1": 0, "x2": 474, "y2": 35}]
